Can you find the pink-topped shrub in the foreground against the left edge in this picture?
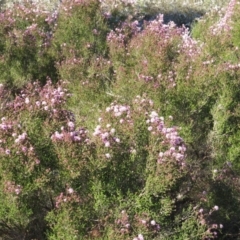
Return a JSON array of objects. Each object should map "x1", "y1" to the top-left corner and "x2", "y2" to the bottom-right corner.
[{"x1": 0, "y1": 80, "x2": 70, "y2": 239}]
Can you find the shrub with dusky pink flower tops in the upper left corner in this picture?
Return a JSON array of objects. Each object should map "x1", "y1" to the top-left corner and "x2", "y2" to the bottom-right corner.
[{"x1": 0, "y1": 2, "x2": 57, "y2": 88}]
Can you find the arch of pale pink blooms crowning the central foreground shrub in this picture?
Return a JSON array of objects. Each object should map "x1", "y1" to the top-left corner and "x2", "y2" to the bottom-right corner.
[{"x1": 93, "y1": 96, "x2": 186, "y2": 167}]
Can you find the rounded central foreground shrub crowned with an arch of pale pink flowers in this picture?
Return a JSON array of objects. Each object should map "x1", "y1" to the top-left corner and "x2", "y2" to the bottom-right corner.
[{"x1": 88, "y1": 96, "x2": 189, "y2": 239}]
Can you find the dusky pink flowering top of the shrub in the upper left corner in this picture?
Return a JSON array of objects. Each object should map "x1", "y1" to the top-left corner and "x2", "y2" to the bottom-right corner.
[{"x1": 0, "y1": 3, "x2": 57, "y2": 51}]
